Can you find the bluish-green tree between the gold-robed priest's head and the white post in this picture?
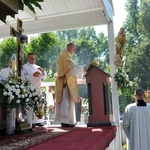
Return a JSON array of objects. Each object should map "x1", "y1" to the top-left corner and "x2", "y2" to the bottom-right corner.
[{"x1": 57, "y1": 27, "x2": 109, "y2": 69}]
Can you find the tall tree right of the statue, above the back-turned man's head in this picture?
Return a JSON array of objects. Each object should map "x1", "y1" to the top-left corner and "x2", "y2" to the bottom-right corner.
[{"x1": 125, "y1": 0, "x2": 150, "y2": 89}]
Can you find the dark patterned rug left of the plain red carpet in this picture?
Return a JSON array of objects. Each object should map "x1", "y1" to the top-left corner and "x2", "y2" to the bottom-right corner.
[{"x1": 0, "y1": 127, "x2": 74, "y2": 150}]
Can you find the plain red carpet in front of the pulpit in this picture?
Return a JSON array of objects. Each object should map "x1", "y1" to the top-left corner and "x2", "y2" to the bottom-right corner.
[{"x1": 27, "y1": 126, "x2": 116, "y2": 150}]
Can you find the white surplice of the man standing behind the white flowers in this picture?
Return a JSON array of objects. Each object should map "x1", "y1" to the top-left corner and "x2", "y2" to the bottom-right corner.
[{"x1": 22, "y1": 63, "x2": 47, "y2": 124}]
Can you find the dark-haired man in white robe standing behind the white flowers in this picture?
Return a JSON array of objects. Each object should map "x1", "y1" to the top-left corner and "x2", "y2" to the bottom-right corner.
[{"x1": 22, "y1": 53, "x2": 47, "y2": 127}]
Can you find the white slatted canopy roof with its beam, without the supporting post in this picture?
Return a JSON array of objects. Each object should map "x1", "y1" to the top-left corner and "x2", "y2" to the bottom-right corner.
[{"x1": 0, "y1": 0, "x2": 113, "y2": 38}]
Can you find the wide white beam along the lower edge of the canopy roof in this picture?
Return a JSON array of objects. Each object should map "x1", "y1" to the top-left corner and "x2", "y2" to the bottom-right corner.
[{"x1": 0, "y1": 10, "x2": 108, "y2": 38}]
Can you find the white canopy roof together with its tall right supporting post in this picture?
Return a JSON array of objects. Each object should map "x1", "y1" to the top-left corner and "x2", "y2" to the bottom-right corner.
[{"x1": 0, "y1": 0, "x2": 121, "y2": 149}]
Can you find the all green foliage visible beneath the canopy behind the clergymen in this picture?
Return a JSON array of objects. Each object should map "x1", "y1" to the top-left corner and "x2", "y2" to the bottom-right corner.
[{"x1": 0, "y1": 27, "x2": 109, "y2": 81}]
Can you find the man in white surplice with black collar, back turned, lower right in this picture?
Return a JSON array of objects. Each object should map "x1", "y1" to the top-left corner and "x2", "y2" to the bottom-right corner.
[{"x1": 123, "y1": 89, "x2": 150, "y2": 150}]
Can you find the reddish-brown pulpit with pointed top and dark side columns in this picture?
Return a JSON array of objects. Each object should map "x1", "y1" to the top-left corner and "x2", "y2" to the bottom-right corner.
[{"x1": 86, "y1": 66, "x2": 112, "y2": 127}]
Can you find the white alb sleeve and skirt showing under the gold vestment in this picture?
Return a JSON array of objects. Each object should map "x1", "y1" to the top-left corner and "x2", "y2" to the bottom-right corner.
[{"x1": 55, "y1": 66, "x2": 84, "y2": 124}]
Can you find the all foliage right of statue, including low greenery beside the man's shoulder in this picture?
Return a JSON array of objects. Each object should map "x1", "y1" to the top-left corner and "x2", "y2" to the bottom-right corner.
[{"x1": 119, "y1": 0, "x2": 150, "y2": 112}]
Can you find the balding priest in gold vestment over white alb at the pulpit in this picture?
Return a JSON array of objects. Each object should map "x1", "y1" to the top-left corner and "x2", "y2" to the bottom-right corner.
[{"x1": 55, "y1": 43, "x2": 88, "y2": 127}]
